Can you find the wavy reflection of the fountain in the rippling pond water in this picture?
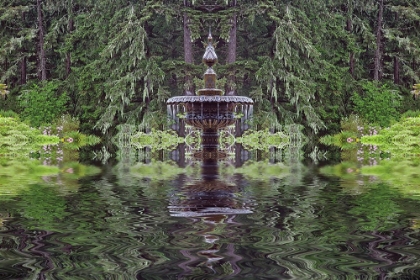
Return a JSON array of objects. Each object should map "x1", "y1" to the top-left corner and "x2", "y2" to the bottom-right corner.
[{"x1": 168, "y1": 146, "x2": 255, "y2": 279}]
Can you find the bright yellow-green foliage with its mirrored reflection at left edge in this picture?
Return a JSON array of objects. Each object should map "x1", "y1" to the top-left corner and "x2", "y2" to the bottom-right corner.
[{"x1": 0, "y1": 112, "x2": 99, "y2": 197}]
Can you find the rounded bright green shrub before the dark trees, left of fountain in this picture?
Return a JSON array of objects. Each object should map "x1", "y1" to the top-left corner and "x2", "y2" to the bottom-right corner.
[{"x1": 20, "y1": 81, "x2": 69, "y2": 127}]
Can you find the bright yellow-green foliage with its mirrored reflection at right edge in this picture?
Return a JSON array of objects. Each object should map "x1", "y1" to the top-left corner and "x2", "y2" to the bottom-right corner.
[{"x1": 321, "y1": 111, "x2": 420, "y2": 198}]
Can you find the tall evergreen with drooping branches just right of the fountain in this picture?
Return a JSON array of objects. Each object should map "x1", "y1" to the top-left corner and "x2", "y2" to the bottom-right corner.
[{"x1": 249, "y1": 1, "x2": 324, "y2": 133}]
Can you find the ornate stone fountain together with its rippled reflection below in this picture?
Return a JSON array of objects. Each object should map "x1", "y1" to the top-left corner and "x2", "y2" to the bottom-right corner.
[{"x1": 167, "y1": 33, "x2": 254, "y2": 277}]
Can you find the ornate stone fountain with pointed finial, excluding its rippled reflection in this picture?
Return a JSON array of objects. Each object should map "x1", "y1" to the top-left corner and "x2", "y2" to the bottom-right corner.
[{"x1": 167, "y1": 33, "x2": 254, "y2": 179}]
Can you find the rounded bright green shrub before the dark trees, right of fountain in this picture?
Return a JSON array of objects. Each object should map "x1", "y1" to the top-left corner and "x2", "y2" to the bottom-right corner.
[{"x1": 351, "y1": 82, "x2": 401, "y2": 127}]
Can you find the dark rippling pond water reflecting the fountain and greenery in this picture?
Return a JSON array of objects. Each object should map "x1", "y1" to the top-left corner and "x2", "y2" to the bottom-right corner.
[{"x1": 0, "y1": 144, "x2": 420, "y2": 279}]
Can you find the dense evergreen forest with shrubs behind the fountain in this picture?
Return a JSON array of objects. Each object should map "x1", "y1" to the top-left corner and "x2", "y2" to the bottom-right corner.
[{"x1": 0, "y1": 0, "x2": 420, "y2": 140}]
